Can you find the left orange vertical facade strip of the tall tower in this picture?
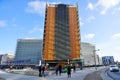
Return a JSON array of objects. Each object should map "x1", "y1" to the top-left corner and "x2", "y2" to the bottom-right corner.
[{"x1": 43, "y1": 6, "x2": 55, "y2": 60}]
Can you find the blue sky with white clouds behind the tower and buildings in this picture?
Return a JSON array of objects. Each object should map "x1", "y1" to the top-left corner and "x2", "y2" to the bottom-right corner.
[{"x1": 0, "y1": 0, "x2": 120, "y2": 61}]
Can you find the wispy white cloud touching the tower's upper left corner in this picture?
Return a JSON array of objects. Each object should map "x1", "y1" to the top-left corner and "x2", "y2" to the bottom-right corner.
[{"x1": 25, "y1": 0, "x2": 46, "y2": 15}]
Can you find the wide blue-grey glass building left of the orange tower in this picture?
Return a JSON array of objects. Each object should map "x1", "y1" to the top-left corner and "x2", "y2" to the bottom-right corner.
[{"x1": 14, "y1": 39, "x2": 43, "y2": 65}]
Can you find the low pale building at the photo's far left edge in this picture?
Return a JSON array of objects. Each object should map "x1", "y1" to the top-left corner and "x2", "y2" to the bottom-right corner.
[{"x1": 1, "y1": 53, "x2": 14, "y2": 65}]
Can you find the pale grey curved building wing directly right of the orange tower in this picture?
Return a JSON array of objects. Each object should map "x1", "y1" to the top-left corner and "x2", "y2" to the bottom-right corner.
[{"x1": 81, "y1": 42, "x2": 100, "y2": 66}]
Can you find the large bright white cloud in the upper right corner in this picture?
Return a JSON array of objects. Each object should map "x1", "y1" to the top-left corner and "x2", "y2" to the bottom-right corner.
[{"x1": 96, "y1": 0, "x2": 120, "y2": 15}]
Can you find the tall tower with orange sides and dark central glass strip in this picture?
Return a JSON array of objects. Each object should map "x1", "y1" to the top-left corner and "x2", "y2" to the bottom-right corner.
[{"x1": 43, "y1": 4, "x2": 80, "y2": 61}]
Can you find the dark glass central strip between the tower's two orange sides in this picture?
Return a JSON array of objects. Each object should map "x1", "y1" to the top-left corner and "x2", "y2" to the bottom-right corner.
[{"x1": 55, "y1": 4, "x2": 70, "y2": 60}]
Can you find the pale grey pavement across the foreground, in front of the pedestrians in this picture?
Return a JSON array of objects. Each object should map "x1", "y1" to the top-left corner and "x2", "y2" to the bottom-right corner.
[{"x1": 0, "y1": 67, "x2": 109, "y2": 80}]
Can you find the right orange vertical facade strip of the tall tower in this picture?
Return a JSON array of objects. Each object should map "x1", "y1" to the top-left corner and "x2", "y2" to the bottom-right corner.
[{"x1": 69, "y1": 6, "x2": 80, "y2": 59}]
